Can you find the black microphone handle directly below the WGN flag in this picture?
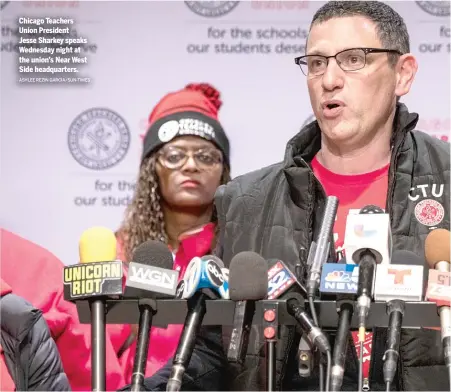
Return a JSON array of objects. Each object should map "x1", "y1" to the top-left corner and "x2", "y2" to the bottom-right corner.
[{"x1": 131, "y1": 298, "x2": 157, "y2": 392}]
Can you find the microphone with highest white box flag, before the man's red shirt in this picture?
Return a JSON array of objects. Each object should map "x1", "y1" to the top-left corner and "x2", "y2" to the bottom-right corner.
[{"x1": 344, "y1": 205, "x2": 392, "y2": 391}]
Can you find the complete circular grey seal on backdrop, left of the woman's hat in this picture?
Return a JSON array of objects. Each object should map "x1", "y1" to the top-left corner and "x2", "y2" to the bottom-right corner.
[{"x1": 68, "y1": 108, "x2": 130, "y2": 170}]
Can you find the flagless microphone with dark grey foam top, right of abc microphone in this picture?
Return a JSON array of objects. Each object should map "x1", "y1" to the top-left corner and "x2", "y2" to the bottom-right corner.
[{"x1": 227, "y1": 252, "x2": 268, "y2": 365}]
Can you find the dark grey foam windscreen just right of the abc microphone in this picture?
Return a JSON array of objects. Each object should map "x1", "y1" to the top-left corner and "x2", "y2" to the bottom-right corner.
[{"x1": 229, "y1": 252, "x2": 268, "y2": 301}]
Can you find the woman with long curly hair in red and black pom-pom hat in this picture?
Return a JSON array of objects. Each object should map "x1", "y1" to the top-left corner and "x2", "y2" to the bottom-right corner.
[{"x1": 118, "y1": 84, "x2": 230, "y2": 382}]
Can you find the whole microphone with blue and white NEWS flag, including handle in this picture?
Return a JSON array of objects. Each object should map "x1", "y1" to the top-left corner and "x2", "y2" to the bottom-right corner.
[{"x1": 320, "y1": 259, "x2": 359, "y2": 391}]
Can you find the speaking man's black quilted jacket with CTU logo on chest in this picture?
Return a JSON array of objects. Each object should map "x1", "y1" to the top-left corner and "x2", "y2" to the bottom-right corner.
[{"x1": 139, "y1": 104, "x2": 450, "y2": 391}]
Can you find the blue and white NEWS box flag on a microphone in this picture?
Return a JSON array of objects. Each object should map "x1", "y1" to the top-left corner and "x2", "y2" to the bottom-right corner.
[{"x1": 319, "y1": 263, "x2": 359, "y2": 294}]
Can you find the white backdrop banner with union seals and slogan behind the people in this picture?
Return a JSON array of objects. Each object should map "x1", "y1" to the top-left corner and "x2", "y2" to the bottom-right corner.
[{"x1": 0, "y1": 1, "x2": 450, "y2": 264}]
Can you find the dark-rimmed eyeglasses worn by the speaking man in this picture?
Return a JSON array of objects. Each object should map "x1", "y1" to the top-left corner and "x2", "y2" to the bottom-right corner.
[{"x1": 294, "y1": 48, "x2": 402, "y2": 76}]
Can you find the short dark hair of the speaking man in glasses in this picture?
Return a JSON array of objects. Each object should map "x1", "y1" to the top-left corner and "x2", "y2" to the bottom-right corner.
[{"x1": 310, "y1": 1, "x2": 410, "y2": 65}]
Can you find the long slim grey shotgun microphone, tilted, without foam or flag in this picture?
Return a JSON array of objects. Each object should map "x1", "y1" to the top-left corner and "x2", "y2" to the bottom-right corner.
[{"x1": 307, "y1": 196, "x2": 338, "y2": 298}]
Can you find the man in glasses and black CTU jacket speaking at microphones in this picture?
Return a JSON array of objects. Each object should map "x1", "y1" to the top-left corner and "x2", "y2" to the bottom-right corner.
[{"x1": 132, "y1": 1, "x2": 450, "y2": 391}]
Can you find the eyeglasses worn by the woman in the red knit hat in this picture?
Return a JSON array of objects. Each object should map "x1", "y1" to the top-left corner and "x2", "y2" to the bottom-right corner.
[{"x1": 158, "y1": 147, "x2": 222, "y2": 170}]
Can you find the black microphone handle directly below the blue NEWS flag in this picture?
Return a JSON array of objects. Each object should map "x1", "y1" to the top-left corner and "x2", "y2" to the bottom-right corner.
[{"x1": 330, "y1": 299, "x2": 354, "y2": 392}]
